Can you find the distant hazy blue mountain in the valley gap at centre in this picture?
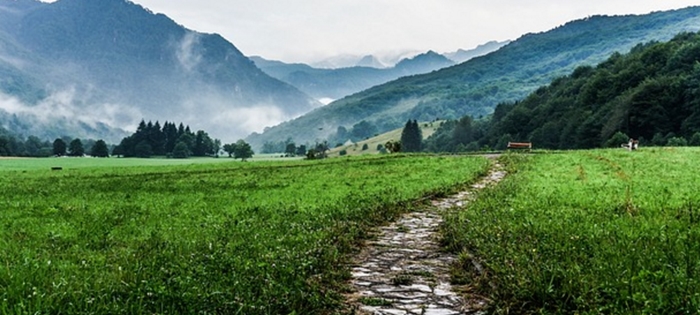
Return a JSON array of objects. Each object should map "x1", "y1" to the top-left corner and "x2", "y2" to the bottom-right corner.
[{"x1": 251, "y1": 51, "x2": 454, "y2": 100}]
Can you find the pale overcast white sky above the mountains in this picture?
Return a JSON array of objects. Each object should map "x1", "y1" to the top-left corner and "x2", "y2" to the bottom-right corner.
[{"x1": 106, "y1": 0, "x2": 698, "y2": 63}]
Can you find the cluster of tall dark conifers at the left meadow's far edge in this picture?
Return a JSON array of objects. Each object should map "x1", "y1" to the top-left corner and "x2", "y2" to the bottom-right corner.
[{"x1": 112, "y1": 120, "x2": 221, "y2": 158}]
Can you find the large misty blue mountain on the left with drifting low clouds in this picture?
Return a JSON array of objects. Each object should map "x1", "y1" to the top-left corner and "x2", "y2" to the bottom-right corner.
[{"x1": 0, "y1": 0, "x2": 321, "y2": 141}]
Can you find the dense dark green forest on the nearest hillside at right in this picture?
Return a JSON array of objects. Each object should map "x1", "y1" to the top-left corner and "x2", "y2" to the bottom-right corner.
[{"x1": 425, "y1": 33, "x2": 700, "y2": 152}]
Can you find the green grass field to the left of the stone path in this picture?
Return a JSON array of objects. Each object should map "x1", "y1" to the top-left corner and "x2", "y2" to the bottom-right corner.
[{"x1": 0, "y1": 155, "x2": 489, "y2": 314}]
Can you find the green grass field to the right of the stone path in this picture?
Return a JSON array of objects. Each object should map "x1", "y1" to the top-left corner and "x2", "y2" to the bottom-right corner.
[{"x1": 444, "y1": 148, "x2": 700, "y2": 314}]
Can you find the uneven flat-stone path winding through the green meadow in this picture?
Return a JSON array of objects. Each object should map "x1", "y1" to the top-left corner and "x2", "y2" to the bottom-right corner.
[{"x1": 348, "y1": 164, "x2": 506, "y2": 315}]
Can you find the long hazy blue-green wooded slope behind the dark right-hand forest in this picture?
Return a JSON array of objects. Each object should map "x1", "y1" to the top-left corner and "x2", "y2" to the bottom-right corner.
[{"x1": 248, "y1": 7, "x2": 700, "y2": 146}]
